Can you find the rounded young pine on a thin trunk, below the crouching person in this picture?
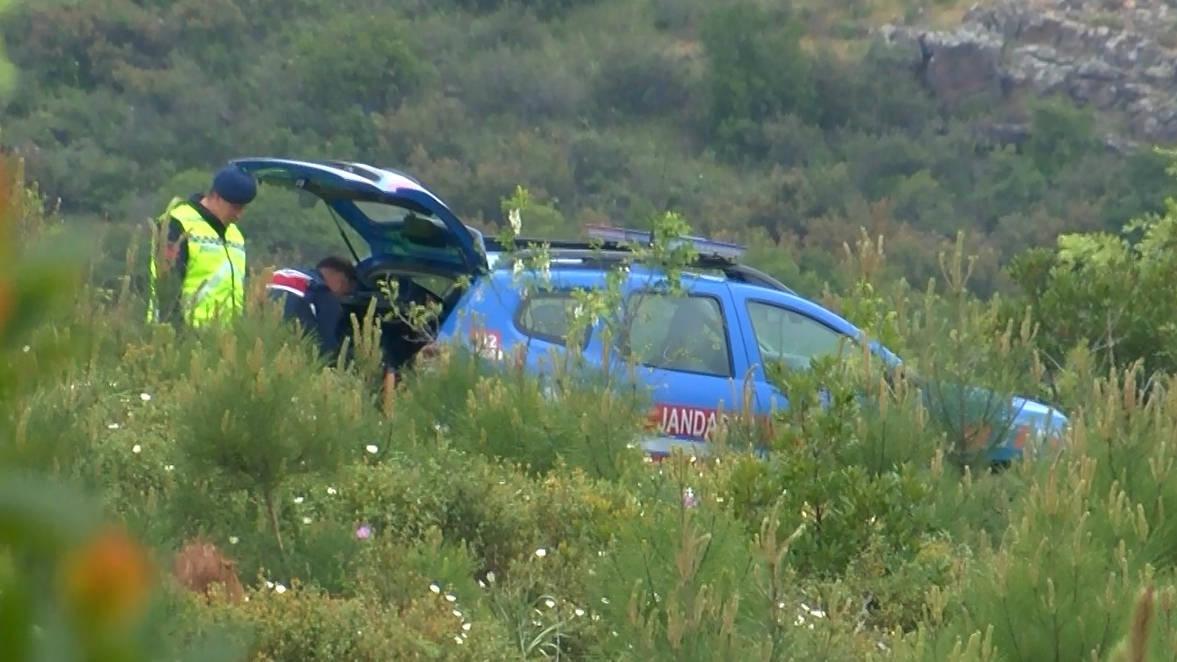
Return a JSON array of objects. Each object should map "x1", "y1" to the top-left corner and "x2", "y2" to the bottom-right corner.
[{"x1": 167, "y1": 306, "x2": 373, "y2": 551}]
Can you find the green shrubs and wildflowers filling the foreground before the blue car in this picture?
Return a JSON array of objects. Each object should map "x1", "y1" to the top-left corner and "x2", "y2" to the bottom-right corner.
[{"x1": 0, "y1": 141, "x2": 1177, "y2": 661}]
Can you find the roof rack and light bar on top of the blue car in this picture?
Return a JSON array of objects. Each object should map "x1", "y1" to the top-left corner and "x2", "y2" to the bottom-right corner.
[{"x1": 485, "y1": 225, "x2": 797, "y2": 294}]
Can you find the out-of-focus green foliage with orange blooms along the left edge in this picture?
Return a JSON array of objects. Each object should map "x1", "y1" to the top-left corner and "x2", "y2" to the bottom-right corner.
[{"x1": 0, "y1": 158, "x2": 242, "y2": 662}]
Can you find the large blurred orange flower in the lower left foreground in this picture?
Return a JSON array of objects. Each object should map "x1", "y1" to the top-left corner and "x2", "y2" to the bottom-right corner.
[{"x1": 61, "y1": 528, "x2": 152, "y2": 627}]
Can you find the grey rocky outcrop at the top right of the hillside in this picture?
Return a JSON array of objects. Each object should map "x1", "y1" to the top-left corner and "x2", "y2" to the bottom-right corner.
[{"x1": 879, "y1": 0, "x2": 1177, "y2": 143}]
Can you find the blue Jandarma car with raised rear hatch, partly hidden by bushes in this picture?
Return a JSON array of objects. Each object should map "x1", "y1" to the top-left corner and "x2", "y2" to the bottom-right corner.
[{"x1": 234, "y1": 158, "x2": 1068, "y2": 462}]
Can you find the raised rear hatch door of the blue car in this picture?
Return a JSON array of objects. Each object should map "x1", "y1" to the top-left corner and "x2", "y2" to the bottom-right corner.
[{"x1": 232, "y1": 158, "x2": 487, "y2": 274}]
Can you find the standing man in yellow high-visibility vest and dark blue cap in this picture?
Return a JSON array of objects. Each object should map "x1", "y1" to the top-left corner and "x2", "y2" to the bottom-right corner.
[{"x1": 147, "y1": 165, "x2": 258, "y2": 326}]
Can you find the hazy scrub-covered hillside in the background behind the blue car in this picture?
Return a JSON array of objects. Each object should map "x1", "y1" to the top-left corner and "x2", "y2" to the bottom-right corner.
[{"x1": 0, "y1": 0, "x2": 1169, "y2": 293}]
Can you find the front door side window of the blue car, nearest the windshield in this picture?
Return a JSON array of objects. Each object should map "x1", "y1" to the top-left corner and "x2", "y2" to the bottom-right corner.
[{"x1": 747, "y1": 302, "x2": 849, "y2": 370}]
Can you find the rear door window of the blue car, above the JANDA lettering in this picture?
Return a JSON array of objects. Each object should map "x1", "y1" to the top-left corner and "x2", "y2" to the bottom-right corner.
[{"x1": 618, "y1": 292, "x2": 732, "y2": 377}]
